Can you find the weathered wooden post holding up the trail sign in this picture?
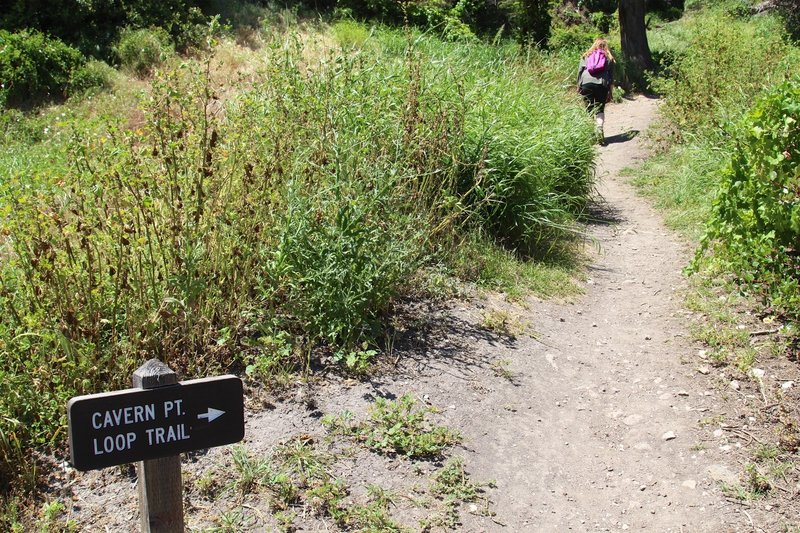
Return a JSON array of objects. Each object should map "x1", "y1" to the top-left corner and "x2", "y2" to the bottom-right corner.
[{"x1": 133, "y1": 359, "x2": 184, "y2": 533}]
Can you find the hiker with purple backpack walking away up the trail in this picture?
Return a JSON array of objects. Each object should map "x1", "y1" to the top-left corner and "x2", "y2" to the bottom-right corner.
[{"x1": 578, "y1": 37, "x2": 614, "y2": 145}]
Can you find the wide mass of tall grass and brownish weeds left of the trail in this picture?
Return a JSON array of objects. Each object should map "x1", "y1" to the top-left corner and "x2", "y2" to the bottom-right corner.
[{"x1": 0, "y1": 22, "x2": 594, "y2": 502}]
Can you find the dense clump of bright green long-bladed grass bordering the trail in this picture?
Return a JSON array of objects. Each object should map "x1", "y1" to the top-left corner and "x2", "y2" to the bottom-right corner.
[{"x1": 394, "y1": 32, "x2": 594, "y2": 256}]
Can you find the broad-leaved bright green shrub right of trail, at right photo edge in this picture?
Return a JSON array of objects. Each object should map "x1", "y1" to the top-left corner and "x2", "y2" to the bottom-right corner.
[{"x1": 700, "y1": 76, "x2": 800, "y2": 320}]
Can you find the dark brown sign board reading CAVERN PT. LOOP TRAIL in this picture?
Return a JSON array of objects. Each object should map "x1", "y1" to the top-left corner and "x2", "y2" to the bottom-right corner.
[{"x1": 67, "y1": 376, "x2": 244, "y2": 470}]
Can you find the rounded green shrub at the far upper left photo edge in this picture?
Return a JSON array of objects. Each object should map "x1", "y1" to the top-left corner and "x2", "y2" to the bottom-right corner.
[{"x1": 0, "y1": 30, "x2": 85, "y2": 106}]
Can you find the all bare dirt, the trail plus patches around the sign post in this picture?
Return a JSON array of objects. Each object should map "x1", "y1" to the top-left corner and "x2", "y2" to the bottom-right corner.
[{"x1": 62, "y1": 93, "x2": 752, "y2": 533}]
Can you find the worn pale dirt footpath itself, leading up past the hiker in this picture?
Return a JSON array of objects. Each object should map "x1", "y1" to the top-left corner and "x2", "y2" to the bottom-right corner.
[{"x1": 444, "y1": 97, "x2": 742, "y2": 532}]
